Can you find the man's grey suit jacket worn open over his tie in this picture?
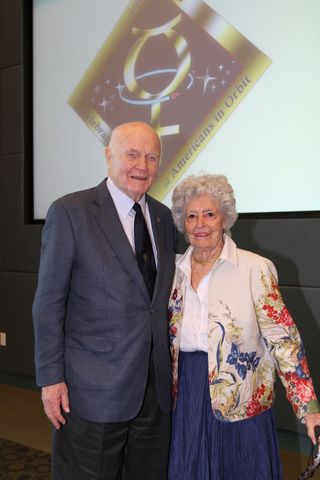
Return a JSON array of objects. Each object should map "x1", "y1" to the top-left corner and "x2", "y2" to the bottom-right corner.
[{"x1": 33, "y1": 180, "x2": 175, "y2": 422}]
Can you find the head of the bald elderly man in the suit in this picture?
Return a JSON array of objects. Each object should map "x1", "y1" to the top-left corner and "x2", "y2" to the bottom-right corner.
[{"x1": 105, "y1": 123, "x2": 161, "y2": 202}]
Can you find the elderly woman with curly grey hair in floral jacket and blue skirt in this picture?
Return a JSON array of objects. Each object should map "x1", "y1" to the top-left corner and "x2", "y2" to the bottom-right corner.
[{"x1": 169, "y1": 175, "x2": 320, "y2": 480}]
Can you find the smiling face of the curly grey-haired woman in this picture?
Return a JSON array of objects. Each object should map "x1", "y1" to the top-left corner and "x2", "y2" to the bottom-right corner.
[{"x1": 184, "y1": 195, "x2": 224, "y2": 252}]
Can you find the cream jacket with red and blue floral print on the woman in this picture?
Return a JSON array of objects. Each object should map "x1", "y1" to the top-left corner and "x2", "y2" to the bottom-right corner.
[{"x1": 169, "y1": 235, "x2": 320, "y2": 421}]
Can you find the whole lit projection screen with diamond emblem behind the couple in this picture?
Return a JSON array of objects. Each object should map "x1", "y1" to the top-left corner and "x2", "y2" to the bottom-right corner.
[{"x1": 33, "y1": 0, "x2": 320, "y2": 220}]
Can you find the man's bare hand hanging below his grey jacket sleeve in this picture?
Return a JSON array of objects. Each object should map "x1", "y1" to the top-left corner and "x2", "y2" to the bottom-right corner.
[{"x1": 42, "y1": 382, "x2": 70, "y2": 430}]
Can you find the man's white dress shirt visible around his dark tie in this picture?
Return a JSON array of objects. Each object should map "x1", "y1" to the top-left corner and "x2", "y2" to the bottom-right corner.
[{"x1": 106, "y1": 177, "x2": 158, "y2": 266}]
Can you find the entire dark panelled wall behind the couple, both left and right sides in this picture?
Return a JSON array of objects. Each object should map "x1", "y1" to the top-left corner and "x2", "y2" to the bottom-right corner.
[{"x1": 0, "y1": 0, "x2": 320, "y2": 431}]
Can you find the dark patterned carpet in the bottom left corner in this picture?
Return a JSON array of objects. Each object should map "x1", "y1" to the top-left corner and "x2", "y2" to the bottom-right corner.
[{"x1": 0, "y1": 438, "x2": 51, "y2": 480}]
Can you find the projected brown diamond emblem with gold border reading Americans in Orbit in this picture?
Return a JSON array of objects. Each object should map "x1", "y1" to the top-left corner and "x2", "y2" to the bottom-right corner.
[{"x1": 68, "y1": 0, "x2": 271, "y2": 200}]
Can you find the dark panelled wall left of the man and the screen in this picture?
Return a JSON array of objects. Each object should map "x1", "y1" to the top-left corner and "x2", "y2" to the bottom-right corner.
[{"x1": 0, "y1": 0, "x2": 41, "y2": 375}]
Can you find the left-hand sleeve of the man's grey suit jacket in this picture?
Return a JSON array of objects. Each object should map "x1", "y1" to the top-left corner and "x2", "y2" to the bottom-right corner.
[{"x1": 33, "y1": 200, "x2": 76, "y2": 386}]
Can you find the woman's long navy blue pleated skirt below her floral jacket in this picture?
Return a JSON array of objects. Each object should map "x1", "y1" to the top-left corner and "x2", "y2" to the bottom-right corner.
[{"x1": 168, "y1": 352, "x2": 283, "y2": 480}]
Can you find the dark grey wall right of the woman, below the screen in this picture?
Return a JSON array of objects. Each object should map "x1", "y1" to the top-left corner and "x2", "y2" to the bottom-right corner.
[{"x1": 233, "y1": 218, "x2": 320, "y2": 432}]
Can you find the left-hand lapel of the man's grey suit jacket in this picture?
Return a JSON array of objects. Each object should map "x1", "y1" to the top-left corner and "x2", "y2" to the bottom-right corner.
[{"x1": 94, "y1": 180, "x2": 149, "y2": 299}]
